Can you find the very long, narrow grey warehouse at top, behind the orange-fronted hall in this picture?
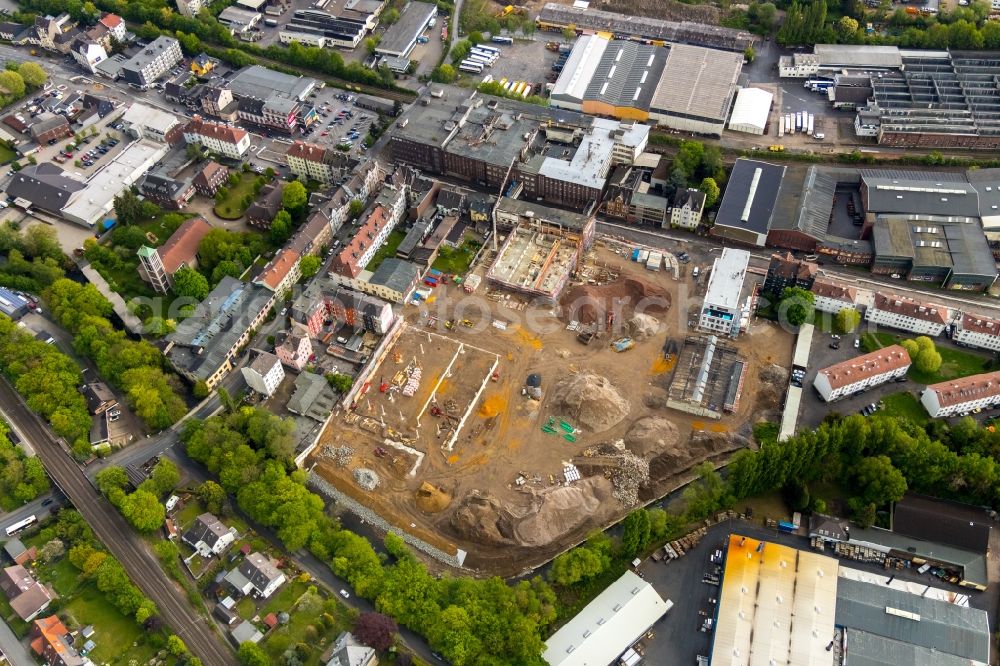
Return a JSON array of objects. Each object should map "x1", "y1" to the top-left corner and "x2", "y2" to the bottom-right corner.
[{"x1": 535, "y1": 2, "x2": 754, "y2": 54}]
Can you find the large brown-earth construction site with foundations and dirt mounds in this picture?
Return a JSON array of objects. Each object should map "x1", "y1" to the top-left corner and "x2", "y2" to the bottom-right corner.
[{"x1": 306, "y1": 241, "x2": 792, "y2": 576}]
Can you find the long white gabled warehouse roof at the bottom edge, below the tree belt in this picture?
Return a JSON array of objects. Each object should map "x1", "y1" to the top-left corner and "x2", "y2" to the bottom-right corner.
[{"x1": 542, "y1": 571, "x2": 673, "y2": 666}]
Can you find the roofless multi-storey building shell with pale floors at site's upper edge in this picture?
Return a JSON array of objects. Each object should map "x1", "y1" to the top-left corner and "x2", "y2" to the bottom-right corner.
[{"x1": 486, "y1": 197, "x2": 594, "y2": 303}]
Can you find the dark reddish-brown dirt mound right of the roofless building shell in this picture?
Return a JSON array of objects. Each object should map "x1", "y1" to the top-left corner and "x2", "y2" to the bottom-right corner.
[{"x1": 559, "y1": 279, "x2": 670, "y2": 324}]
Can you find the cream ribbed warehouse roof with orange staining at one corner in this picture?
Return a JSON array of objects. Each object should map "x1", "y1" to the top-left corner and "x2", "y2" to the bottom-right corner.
[{"x1": 712, "y1": 534, "x2": 837, "y2": 666}]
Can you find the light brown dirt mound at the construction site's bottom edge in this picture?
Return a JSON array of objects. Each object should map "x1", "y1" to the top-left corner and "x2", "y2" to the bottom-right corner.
[{"x1": 514, "y1": 476, "x2": 611, "y2": 546}]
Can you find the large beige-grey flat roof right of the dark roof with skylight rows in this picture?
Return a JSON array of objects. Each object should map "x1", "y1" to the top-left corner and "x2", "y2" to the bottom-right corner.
[{"x1": 651, "y1": 44, "x2": 743, "y2": 122}]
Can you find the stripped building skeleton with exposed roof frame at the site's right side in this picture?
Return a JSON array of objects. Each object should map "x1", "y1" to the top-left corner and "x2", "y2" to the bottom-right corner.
[{"x1": 667, "y1": 335, "x2": 747, "y2": 419}]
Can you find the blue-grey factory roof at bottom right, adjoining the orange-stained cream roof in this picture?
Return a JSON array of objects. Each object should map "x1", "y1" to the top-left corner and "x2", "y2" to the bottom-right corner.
[{"x1": 836, "y1": 572, "x2": 990, "y2": 664}]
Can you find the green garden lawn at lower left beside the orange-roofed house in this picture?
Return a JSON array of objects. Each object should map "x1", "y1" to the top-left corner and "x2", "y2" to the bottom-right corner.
[{"x1": 59, "y1": 584, "x2": 156, "y2": 664}]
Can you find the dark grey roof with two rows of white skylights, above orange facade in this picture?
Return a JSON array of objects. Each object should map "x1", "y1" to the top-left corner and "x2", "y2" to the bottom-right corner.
[{"x1": 584, "y1": 40, "x2": 667, "y2": 109}]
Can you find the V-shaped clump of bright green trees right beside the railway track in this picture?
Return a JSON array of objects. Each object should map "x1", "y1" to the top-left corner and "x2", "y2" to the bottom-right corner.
[{"x1": 96, "y1": 458, "x2": 181, "y2": 534}]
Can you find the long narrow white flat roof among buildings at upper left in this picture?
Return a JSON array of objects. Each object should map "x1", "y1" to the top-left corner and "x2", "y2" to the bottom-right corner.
[{"x1": 62, "y1": 139, "x2": 167, "y2": 225}]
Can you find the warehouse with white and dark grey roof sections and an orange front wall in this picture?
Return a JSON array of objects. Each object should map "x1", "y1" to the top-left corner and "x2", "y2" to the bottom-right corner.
[{"x1": 549, "y1": 35, "x2": 667, "y2": 122}]
